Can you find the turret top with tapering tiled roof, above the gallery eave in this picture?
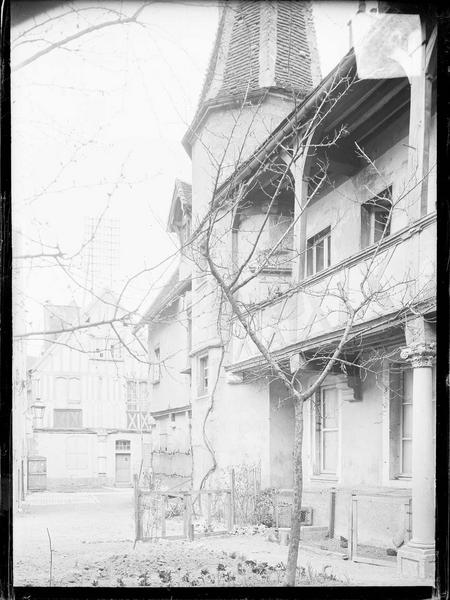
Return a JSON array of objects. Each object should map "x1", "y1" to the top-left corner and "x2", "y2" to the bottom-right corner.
[{"x1": 183, "y1": 0, "x2": 321, "y2": 214}]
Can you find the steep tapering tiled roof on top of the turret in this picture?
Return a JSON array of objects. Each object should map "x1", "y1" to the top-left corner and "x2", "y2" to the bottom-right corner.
[{"x1": 185, "y1": 0, "x2": 321, "y2": 151}]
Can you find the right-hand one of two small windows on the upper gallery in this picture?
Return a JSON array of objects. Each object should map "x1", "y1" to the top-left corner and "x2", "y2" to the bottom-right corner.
[{"x1": 361, "y1": 187, "x2": 392, "y2": 248}]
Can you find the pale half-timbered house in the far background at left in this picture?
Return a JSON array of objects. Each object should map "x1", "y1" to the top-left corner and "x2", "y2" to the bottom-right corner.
[{"x1": 27, "y1": 292, "x2": 152, "y2": 492}]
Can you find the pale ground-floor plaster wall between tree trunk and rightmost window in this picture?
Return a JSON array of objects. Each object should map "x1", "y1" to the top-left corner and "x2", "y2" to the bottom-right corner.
[{"x1": 303, "y1": 363, "x2": 410, "y2": 547}]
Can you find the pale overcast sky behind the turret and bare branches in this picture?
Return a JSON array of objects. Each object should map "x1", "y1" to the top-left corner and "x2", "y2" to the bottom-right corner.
[{"x1": 11, "y1": 1, "x2": 357, "y2": 336}]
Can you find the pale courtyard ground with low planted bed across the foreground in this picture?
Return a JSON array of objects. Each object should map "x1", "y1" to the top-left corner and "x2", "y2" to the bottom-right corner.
[{"x1": 14, "y1": 489, "x2": 423, "y2": 586}]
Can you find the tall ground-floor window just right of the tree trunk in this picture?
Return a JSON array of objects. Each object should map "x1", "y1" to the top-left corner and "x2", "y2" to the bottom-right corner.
[{"x1": 314, "y1": 387, "x2": 339, "y2": 475}]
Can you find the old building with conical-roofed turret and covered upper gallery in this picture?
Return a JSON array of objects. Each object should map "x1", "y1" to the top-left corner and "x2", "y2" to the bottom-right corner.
[{"x1": 141, "y1": 2, "x2": 436, "y2": 577}]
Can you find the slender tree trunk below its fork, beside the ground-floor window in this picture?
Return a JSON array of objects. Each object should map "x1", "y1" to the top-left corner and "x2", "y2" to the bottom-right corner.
[{"x1": 286, "y1": 399, "x2": 303, "y2": 586}]
